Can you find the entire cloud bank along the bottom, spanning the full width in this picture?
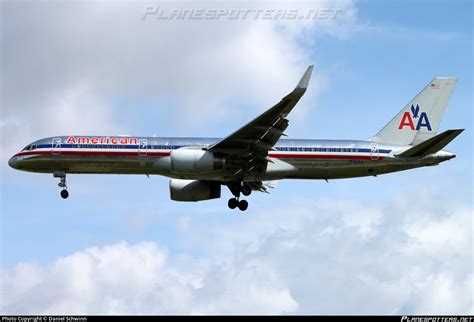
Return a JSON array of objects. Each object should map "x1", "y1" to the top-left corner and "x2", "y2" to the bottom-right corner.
[{"x1": 0, "y1": 193, "x2": 474, "y2": 314}]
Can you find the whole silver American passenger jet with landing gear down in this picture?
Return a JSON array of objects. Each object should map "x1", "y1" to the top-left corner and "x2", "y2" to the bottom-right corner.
[{"x1": 8, "y1": 65, "x2": 464, "y2": 211}]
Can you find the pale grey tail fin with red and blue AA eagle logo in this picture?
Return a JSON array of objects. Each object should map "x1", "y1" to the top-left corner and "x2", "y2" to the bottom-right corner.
[{"x1": 372, "y1": 77, "x2": 456, "y2": 145}]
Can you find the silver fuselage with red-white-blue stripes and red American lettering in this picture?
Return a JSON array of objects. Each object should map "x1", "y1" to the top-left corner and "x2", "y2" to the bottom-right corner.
[{"x1": 9, "y1": 135, "x2": 455, "y2": 182}]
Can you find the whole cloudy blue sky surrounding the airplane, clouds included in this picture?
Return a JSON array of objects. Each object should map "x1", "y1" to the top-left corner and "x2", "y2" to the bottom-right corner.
[{"x1": 0, "y1": 0, "x2": 474, "y2": 314}]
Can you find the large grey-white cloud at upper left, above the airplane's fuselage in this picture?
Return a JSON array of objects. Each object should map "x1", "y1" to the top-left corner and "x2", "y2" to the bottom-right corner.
[{"x1": 0, "y1": 1, "x2": 357, "y2": 163}]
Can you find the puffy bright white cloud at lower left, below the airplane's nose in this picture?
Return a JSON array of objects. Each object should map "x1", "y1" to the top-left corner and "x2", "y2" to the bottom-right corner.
[{"x1": 1, "y1": 242, "x2": 296, "y2": 314}]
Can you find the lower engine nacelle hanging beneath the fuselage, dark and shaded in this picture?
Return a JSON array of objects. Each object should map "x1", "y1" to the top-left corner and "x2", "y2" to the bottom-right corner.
[{"x1": 170, "y1": 179, "x2": 221, "y2": 201}]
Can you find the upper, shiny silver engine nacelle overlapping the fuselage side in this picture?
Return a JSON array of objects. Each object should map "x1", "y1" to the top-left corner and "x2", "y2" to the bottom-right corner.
[{"x1": 170, "y1": 148, "x2": 225, "y2": 173}]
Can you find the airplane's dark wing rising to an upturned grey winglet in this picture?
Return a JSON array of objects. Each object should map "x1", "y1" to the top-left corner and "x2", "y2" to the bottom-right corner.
[{"x1": 208, "y1": 65, "x2": 313, "y2": 171}]
